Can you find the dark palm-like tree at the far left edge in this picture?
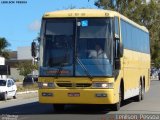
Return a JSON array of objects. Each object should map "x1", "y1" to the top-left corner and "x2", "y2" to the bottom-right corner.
[{"x1": 0, "y1": 37, "x2": 10, "y2": 58}]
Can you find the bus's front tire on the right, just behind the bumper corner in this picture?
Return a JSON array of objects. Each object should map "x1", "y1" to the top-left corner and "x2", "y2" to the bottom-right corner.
[{"x1": 112, "y1": 88, "x2": 122, "y2": 111}]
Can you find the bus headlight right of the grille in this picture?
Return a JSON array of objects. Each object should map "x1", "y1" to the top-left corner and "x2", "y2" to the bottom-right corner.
[{"x1": 92, "y1": 82, "x2": 113, "y2": 88}]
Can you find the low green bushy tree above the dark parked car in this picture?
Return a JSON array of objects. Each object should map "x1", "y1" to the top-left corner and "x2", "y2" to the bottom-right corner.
[{"x1": 17, "y1": 61, "x2": 38, "y2": 76}]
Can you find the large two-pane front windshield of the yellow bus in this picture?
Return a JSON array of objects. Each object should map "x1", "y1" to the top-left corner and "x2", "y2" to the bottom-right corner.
[{"x1": 40, "y1": 18, "x2": 113, "y2": 76}]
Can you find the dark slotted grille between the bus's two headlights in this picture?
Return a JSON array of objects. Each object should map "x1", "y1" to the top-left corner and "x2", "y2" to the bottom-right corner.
[{"x1": 57, "y1": 83, "x2": 92, "y2": 87}]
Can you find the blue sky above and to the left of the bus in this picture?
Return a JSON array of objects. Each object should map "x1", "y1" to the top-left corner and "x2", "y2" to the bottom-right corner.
[{"x1": 0, "y1": 0, "x2": 97, "y2": 51}]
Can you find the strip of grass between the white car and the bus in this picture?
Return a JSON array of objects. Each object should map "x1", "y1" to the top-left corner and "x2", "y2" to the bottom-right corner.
[{"x1": 17, "y1": 83, "x2": 38, "y2": 92}]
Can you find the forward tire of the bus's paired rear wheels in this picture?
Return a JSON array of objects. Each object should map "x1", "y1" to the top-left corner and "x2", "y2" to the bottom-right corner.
[{"x1": 135, "y1": 82, "x2": 144, "y2": 102}]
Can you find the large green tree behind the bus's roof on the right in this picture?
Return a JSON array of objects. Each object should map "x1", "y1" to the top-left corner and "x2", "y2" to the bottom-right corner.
[{"x1": 95, "y1": 0, "x2": 160, "y2": 67}]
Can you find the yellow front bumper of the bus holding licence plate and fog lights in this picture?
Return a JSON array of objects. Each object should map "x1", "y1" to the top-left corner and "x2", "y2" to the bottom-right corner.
[{"x1": 39, "y1": 89, "x2": 118, "y2": 104}]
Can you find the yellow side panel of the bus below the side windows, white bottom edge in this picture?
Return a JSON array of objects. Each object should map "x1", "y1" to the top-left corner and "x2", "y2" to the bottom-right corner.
[{"x1": 123, "y1": 49, "x2": 150, "y2": 99}]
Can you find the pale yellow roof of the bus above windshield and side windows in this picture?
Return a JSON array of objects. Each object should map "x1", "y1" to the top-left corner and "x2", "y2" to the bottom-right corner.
[{"x1": 43, "y1": 9, "x2": 148, "y2": 32}]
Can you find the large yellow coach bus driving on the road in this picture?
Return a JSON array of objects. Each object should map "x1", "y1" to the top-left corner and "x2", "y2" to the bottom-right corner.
[{"x1": 32, "y1": 9, "x2": 150, "y2": 110}]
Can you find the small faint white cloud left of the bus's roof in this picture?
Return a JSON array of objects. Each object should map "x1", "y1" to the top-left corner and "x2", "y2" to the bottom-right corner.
[{"x1": 29, "y1": 20, "x2": 41, "y2": 31}]
